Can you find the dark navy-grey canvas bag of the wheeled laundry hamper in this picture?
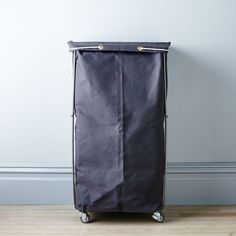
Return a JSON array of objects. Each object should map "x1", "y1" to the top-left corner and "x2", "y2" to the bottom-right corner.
[{"x1": 69, "y1": 42, "x2": 170, "y2": 212}]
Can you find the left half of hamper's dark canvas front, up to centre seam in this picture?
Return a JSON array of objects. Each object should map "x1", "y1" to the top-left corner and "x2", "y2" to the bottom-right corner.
[{"x1": 75, "y1": 52, "x2": 123, "y2": 211}]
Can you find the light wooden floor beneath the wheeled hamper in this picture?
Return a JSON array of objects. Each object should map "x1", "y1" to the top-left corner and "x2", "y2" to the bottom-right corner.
[{"x1": 0, "y1": 205, "x2": 236, "y2": 236}]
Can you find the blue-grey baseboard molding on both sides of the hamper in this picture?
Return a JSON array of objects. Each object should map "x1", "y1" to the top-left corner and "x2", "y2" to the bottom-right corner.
[{"x1": 0, "y1": 162, "x2": 236, "y2": 205}]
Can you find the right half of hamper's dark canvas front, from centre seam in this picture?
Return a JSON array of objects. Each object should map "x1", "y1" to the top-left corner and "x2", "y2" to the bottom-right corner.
[{"x1": 123, "y1": 53, "x2": 164, "y2": 212}]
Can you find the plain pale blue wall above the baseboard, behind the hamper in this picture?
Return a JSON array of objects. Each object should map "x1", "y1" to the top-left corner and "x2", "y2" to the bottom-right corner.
[{"x1": 0, "y1": 0, "x2": 236, "y2": 202}]
